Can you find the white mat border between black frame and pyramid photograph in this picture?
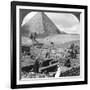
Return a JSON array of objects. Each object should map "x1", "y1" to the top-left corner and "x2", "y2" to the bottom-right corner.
[{"x1": 16, "y1": 6, "x2": 84, "y2": 85}]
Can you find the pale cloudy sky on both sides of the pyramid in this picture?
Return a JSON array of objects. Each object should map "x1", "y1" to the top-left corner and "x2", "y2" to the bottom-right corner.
[{"x1": 22, "y1": 12, "x2": 80, "y2": 34}]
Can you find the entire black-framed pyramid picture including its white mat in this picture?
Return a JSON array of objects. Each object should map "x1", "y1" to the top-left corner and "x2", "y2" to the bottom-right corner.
[{"x1": 12, "y1": 2, "x2": 87, "y2": 87}]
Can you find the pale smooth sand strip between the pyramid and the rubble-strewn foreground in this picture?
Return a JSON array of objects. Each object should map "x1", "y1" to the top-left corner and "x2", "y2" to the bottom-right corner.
[{"x1": 21, "y1": 34, "x2": 80, "y2": 48}]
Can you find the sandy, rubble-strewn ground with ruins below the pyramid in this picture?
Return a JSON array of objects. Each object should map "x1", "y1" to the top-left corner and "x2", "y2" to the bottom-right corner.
[{"x1": 20, "y1": 34, "x2": 80, "y2": 79}]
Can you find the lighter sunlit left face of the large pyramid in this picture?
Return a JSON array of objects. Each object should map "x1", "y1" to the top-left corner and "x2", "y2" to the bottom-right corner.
[{"x1": 23, "y1": 12, "x2": 44, "y2": 33}]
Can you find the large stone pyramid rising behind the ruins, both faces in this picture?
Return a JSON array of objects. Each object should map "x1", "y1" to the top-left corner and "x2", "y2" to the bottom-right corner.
[{"x1": 21, "y1": 12, "x2": 62, "y2": 37}]
